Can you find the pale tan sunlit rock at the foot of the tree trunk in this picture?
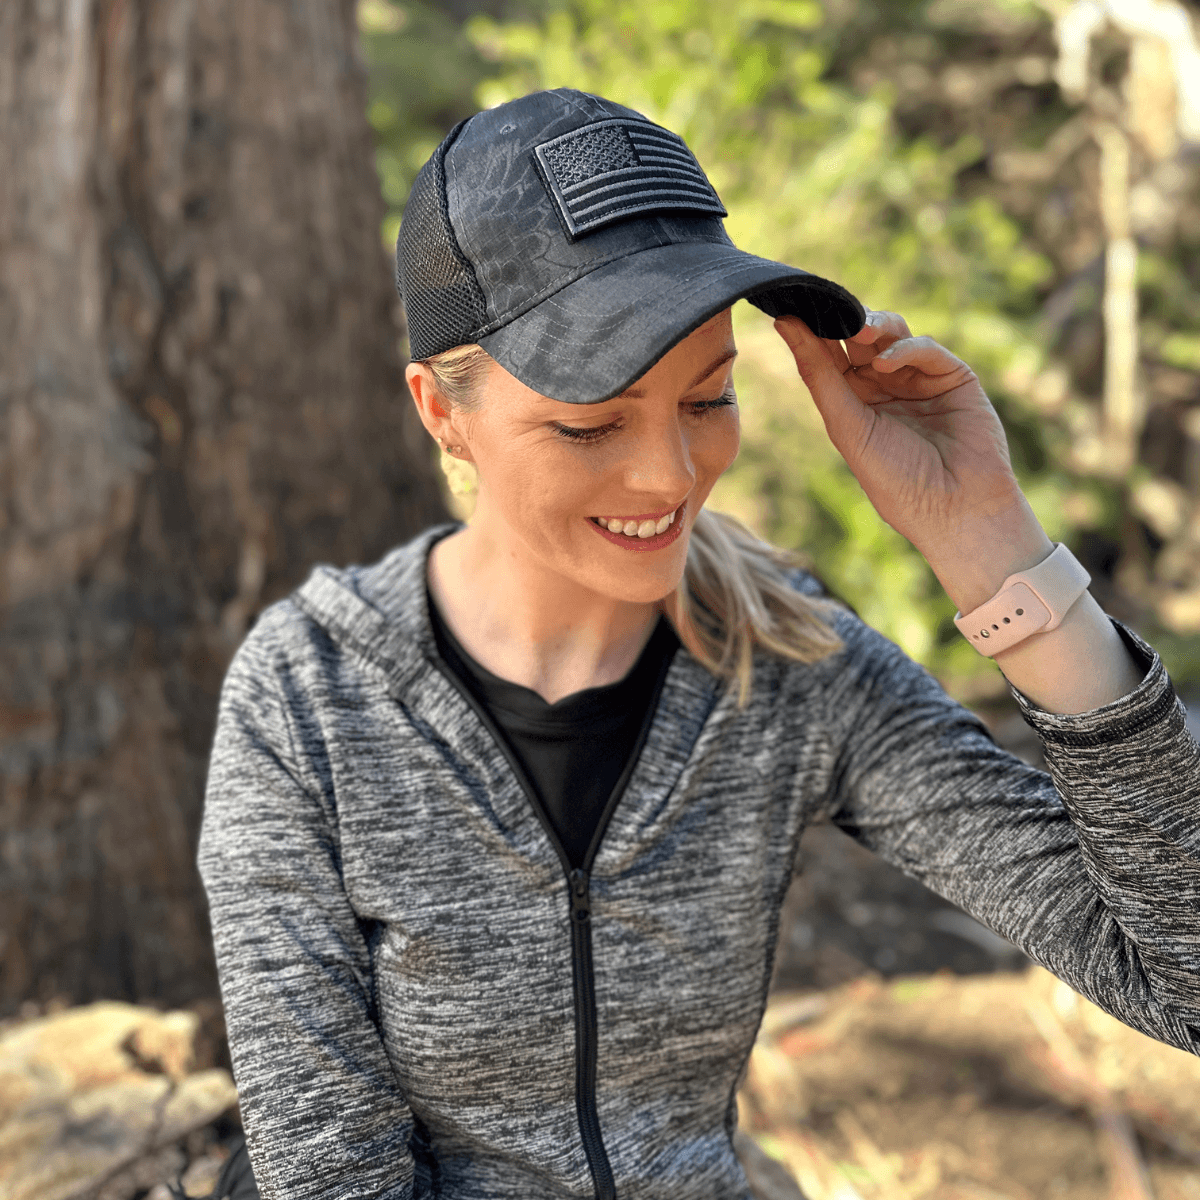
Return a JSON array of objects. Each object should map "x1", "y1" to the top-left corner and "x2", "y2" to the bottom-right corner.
[{"x1": 0, "y1": 1002, "x2": 238, "y2": 1200}]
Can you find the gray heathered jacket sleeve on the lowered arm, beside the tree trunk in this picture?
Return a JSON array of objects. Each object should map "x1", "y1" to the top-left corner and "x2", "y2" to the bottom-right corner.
[{"x1": 199, "y1": 622, "x2": 414, "y2": 1200}]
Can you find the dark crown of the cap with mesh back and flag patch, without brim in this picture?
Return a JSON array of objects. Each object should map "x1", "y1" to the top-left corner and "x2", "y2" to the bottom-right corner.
[{"x1": 396, "y1": 88, "x2": 731, "y2": 359}]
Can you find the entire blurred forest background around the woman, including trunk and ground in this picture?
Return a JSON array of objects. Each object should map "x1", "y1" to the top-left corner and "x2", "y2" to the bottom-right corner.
[{"x1": 0, "y1": 0, "x2": 1200, "y2": 1200}]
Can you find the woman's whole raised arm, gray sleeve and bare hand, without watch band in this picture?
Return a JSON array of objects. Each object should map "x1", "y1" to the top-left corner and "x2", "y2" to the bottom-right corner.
[{"x1": 775, "y1": 312, "x2": 1200, "y2": 1051}]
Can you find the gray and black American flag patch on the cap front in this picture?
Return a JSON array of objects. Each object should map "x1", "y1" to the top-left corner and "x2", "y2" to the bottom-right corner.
[{"x1": 534, "y1": 119, "x2": 728, "y2": 241}]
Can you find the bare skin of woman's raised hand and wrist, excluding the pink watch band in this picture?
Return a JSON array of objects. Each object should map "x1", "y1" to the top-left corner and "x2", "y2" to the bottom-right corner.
[{"x1": 775, "y1": 304, "x2": 1141, "y2": 713}]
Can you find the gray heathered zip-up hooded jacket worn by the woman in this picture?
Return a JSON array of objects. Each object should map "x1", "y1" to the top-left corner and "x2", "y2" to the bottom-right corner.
[{"x1": 199, "y1": 526, "x2": 1200, "y2": 1200}]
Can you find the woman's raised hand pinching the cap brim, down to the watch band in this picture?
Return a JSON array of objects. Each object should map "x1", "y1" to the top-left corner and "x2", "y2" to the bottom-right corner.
[{"x1": 775, "y1": 311, "x2": 1052, "y2": 612}]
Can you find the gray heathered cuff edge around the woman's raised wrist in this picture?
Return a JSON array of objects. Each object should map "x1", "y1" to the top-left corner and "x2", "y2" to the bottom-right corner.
[{"x1": 1008, "y1": 617, "x2": 1186, "y2": 746}]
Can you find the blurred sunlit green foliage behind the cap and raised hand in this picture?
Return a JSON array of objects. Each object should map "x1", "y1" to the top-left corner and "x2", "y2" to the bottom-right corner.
[{"x1": 359, "y1": 0, "x2": 1200, "y2": 698}]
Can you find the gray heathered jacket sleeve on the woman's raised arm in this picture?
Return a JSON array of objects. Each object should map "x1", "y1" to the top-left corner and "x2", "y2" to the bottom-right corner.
[{"x1": 827, "y1": 617, "x2": 1200, "y2": 1054}]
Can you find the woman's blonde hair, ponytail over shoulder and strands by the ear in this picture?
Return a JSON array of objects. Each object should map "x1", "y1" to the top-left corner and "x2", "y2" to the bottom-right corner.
[{"x1": 421, "y1": 344, "x2": 842, "y2": 708}]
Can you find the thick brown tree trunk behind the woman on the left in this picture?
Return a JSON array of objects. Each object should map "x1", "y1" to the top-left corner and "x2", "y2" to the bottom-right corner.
[{"x1": 0, "y1": 0, "x2": 445, "y2": 1012}]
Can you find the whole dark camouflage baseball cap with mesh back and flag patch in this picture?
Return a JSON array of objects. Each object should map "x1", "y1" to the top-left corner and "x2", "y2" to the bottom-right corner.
[{"x1": 396, "y1": 88, "x2": 865, "y2": 404}]
